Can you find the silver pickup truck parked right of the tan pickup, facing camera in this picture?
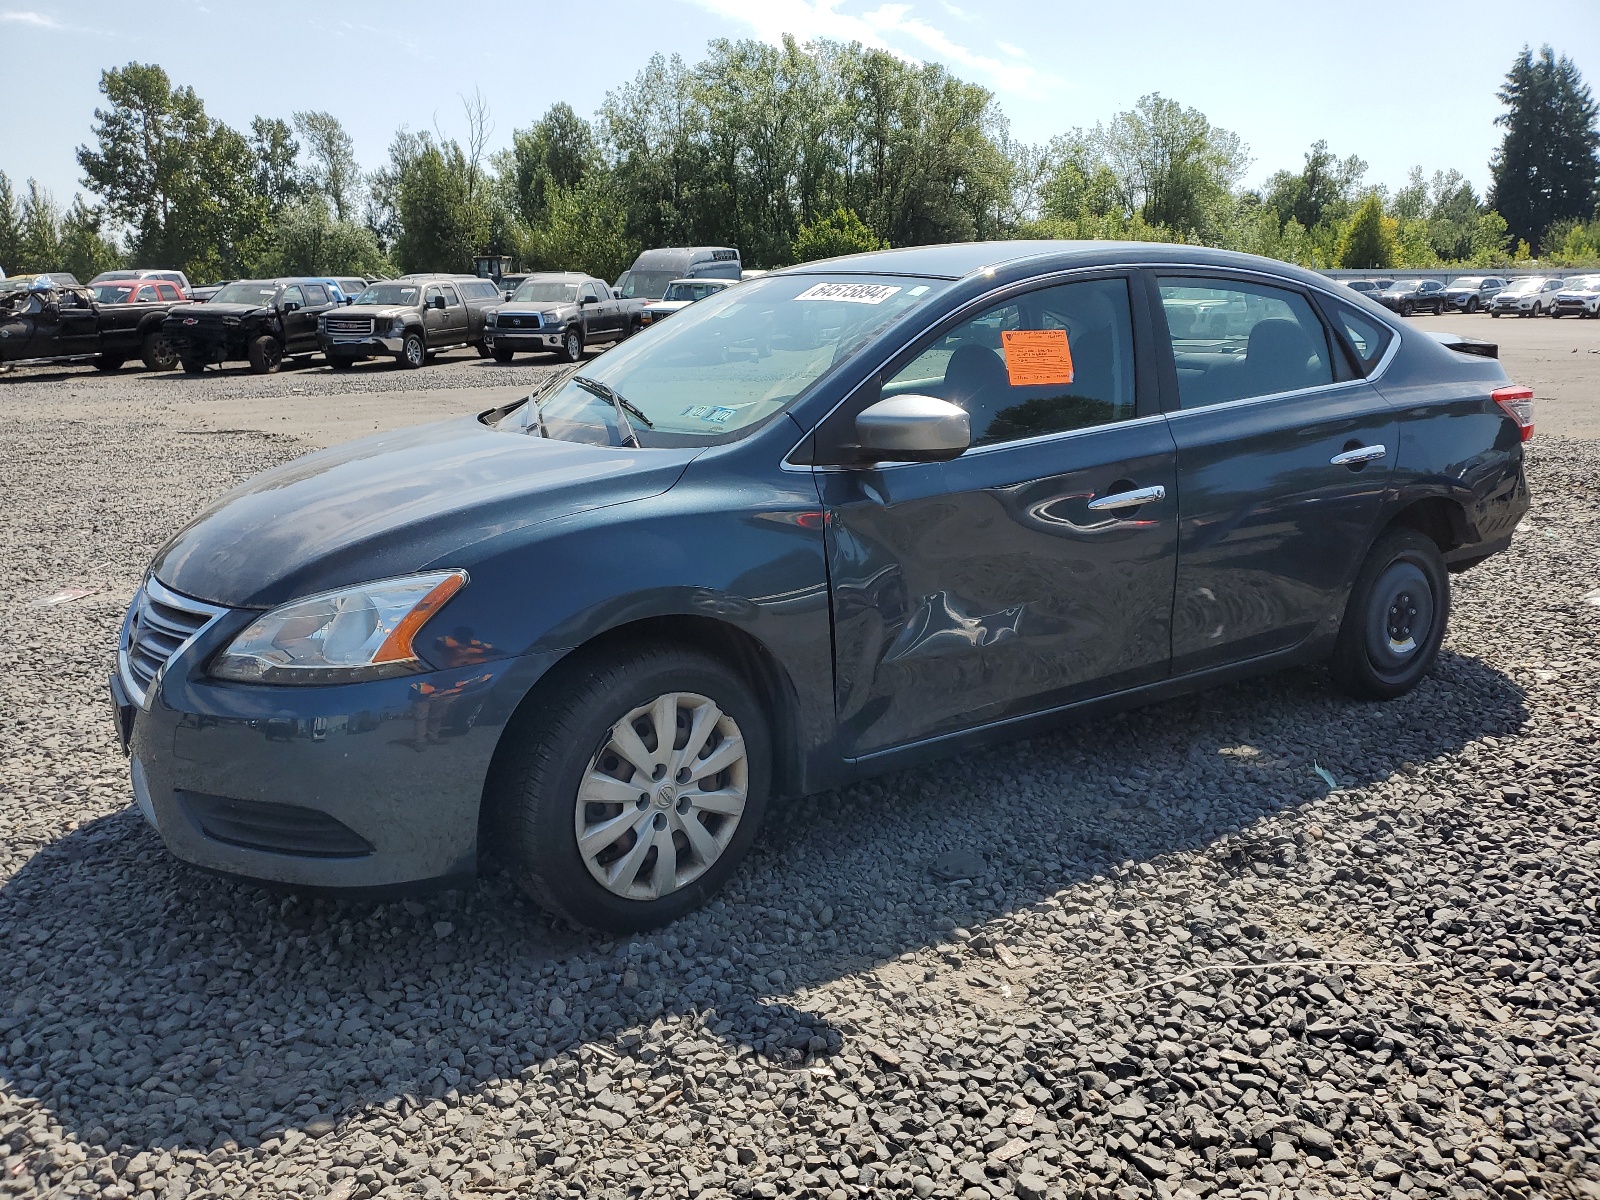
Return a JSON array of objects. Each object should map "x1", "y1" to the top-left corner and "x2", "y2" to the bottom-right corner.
[{"x1": 483, "y1": 272, "x2": 645, "y2": 363}]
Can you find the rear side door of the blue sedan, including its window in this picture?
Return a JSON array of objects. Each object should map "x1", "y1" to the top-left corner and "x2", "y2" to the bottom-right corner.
[{"x1": 1154, "y1": 270, "x2": 1398, "y2": 674}]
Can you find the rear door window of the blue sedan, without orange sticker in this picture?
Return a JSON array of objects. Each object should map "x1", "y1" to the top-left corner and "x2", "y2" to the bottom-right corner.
[{"x1": 1157, "y1": 277, "x2": 1333, "y2": 408}]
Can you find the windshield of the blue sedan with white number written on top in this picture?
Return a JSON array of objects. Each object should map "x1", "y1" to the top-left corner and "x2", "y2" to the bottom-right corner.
[{"x1": 498, "y1": 275, "x2": 950, "y2": 446}]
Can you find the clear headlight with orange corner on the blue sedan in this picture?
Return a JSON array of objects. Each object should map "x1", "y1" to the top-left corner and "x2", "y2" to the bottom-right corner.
[{"x1": 211, "y1": 571, "x2": 467, "y2": 683}]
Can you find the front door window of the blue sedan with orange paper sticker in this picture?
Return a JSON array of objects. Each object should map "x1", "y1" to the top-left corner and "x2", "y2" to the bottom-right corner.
[{"x1": 880, "y1": 278, "x2": 1134, "y2": 446}]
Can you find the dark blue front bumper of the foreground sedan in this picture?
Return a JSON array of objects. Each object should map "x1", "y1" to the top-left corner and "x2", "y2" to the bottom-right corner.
[{"x1": 110, "y1": 592, "x2": 557, "y2": 890}]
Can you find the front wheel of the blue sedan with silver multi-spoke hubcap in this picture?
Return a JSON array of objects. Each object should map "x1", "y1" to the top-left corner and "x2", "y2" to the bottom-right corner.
[{"x1": 488, "y1": 646, "x2": 771, "y2": 933}]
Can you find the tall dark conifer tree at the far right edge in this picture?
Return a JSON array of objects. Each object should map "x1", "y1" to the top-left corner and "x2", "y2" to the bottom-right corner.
[{"x1": 1490, "y1": 46, "x2": 1600, "y2": 251}]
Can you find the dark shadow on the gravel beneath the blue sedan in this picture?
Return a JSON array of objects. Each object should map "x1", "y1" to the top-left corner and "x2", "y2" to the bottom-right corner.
[{"x1": 0, "y1": 653, "x2": 1528, "y2": 1152}]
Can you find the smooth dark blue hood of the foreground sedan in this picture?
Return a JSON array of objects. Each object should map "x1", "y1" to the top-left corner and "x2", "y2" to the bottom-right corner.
[{"x1": 150, "y1": 418, "x2": 699, "y2": 608}]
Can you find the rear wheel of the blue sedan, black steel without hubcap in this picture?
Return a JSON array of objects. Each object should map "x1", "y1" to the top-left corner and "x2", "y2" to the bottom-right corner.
[{"x1": 1333, "y1": 528, "x2": 1450, "y2": 699}]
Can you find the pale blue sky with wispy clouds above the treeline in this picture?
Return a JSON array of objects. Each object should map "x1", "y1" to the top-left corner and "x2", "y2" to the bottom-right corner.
[{"x1": 0, "y1": 0, "x2": 1600, "y2": 214}]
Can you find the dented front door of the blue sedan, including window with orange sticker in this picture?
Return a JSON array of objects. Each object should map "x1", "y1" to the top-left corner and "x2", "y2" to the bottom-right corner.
[{"x1": 816, "y1": 274, "x2": 1178, "y2": 758}]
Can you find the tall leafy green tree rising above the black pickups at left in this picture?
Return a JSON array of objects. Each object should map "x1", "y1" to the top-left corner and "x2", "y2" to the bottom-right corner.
[{"x1": 77, "y1": 62, "x2": 269, "y2": 282}]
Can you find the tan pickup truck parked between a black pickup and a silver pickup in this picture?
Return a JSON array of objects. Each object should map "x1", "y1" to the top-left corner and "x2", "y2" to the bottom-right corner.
[{"x1": 317, "y1": 275, "x2": 501, "y2": 371}]
